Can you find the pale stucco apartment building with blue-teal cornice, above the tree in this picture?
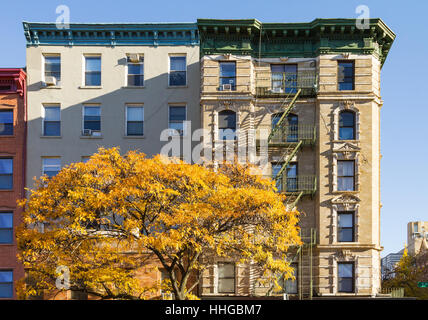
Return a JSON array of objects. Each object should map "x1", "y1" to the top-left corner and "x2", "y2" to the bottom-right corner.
[{"x1": 23, "y1": 22, "x2": 200, "y2": 187}]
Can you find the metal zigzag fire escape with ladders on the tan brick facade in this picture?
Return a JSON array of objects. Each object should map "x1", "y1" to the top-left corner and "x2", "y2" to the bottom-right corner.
[{"x1": 256, "y1": 66, "x2": 317, "y2": 300}]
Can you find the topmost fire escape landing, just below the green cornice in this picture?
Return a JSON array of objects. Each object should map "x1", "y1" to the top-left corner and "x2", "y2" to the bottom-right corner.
[{"x1": 256, "y1": 71, "x2": 317, "y2": 98}]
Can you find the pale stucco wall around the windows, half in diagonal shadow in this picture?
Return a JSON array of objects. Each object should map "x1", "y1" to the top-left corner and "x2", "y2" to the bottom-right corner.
[{"x1": 27, "y1": 46, "x2": 200, "y2": 186}]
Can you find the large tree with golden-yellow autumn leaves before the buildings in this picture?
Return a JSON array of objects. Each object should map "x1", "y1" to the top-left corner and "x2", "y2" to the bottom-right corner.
[{"x1": 17, "y1": 148, "x2": 300, "y2": 299}]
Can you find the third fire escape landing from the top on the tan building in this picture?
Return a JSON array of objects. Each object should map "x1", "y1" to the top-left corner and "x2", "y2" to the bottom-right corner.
[{"x1": 266, "y1": 174, "x2": 317, "y2": 196}]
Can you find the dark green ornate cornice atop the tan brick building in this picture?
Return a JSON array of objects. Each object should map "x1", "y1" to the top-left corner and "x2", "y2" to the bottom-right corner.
[{"x1": 198, "y1": 19, "x2": 395, "y2": 64}]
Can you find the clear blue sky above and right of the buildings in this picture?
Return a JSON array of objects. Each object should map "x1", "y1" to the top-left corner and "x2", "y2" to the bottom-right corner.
[{"x1": 0, "y1": 0, "x2": 428, "y2": 256}]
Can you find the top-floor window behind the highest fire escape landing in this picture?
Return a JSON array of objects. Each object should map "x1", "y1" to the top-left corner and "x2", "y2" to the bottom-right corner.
[{"x1": 271, "y1": 64, "x2": 297, "y2": 93}]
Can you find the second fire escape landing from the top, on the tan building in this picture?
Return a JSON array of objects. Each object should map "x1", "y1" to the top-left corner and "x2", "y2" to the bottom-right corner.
[{"x1": 269, "y1": 124, "x2": 316, "y2": 146}]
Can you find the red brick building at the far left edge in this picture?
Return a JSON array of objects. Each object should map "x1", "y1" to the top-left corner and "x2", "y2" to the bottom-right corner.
[{"x1": 0, "y1": 68, "x2": 27, "y2": 299}]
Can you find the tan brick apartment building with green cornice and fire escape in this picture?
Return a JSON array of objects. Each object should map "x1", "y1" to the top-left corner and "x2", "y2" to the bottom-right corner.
[{"x1": 198, "y1": 19, "x2": 395, "y2": 299}]
